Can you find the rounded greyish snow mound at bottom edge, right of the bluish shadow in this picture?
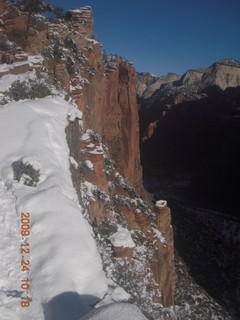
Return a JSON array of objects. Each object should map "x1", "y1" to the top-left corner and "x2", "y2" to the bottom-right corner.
[{"x1": 81, "y1": 303, "x2": 147, "y2": 320}]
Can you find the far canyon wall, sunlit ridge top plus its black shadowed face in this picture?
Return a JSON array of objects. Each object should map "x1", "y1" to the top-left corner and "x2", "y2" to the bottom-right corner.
[{"x1": 138, "y1": 59, "x2": 240, "y2": 216}]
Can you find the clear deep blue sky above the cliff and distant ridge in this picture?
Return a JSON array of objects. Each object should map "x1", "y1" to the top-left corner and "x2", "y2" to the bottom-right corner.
[{"x1": 46, "y1": 0, "x2": 240, "y2": 75}]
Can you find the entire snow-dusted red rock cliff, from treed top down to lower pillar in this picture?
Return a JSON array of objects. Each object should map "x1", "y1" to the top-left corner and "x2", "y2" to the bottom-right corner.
[{"x1": 0, "y1": 0, "x2": 174, "y2": 316}]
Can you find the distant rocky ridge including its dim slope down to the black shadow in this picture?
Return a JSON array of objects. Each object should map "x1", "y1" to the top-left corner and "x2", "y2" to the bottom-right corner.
[{"x1": 137, "y1": 58, "x2": 240, "y2": 141}]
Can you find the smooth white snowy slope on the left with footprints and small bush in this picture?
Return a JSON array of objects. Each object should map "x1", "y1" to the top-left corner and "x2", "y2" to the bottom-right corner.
[{"x1": 0, "y1": 97, "x2": 107, "y2": 320}]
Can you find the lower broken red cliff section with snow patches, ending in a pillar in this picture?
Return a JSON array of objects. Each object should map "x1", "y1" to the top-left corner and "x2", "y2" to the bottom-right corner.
[{"x1": 67, "y1": 120, "x2": 174, "y2": 317}]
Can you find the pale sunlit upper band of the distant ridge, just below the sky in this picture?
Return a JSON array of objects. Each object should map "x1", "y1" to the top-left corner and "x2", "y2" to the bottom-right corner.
[{"x1": 137, "y1": 58, "x2": 240, "y2": 100}]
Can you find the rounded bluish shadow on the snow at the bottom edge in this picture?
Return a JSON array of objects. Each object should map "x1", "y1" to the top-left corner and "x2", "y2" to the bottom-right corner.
[{"x1": 43, "y1": 291, "x2": 99, "y2": 320}]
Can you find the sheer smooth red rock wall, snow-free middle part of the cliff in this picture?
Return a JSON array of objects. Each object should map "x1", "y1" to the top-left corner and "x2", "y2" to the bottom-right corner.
[{"x1": 77, "y1": 59, "x2": 142, "y2": 191}]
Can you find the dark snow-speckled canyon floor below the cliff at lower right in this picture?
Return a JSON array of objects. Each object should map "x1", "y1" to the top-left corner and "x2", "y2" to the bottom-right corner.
[{"x1": 144, "y1": 168, "x2": 240, "y2": 320}]
